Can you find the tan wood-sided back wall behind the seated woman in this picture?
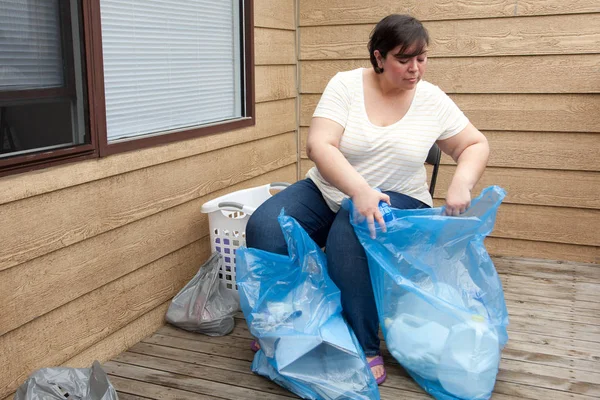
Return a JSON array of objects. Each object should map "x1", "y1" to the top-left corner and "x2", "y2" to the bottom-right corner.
[{"x1": 298, "y1": 0, "x2": 600, "y2": 263}]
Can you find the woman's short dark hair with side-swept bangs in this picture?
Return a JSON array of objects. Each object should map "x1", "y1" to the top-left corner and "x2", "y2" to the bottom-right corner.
[{"x1": 368, "y1": 14, "x2": 429, "y2": 74}]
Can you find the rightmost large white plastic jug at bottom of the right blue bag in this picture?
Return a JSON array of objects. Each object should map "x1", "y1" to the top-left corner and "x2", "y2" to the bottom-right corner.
[{"x1": 438, "y1": 321, "x2": 500, "y2": 398}]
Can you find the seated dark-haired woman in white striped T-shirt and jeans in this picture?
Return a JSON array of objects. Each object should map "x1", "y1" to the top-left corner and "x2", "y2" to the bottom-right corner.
[{"x1": 246, "y1": 15, "x2": 489, "y2": 384}]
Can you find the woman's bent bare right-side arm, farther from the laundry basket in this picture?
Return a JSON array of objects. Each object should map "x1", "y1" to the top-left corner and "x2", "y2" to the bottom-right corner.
[{"x1": 437, "y1": 122, "x2": 490, "y2": 216}]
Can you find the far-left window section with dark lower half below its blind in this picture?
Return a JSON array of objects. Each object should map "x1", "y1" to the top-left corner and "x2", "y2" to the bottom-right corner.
[{"x1": 0, "y1": 0, "x2": 93, "y2": 173}]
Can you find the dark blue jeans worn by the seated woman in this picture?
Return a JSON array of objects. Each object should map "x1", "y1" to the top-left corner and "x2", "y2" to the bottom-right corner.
[{"x1": 246, "y1": 179, "x2": 428, "y2": 357}]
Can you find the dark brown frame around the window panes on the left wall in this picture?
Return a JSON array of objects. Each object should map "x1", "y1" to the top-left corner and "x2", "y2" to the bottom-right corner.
[{"x1": 0, "y1": 0, "x2": 256, "y2": 176}]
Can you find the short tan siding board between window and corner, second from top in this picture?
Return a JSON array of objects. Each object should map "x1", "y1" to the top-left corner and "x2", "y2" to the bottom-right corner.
[{"x1": 254, "y1": 28, "x2": 296, "y2": 65}]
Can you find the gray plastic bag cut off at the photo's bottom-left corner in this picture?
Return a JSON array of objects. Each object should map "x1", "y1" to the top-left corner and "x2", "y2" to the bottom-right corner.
[{"x1": 13, "y1": 361, "x2": 119, "y2": 400}]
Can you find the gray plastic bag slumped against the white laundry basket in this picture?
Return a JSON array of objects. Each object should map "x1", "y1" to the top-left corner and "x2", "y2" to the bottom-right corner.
[{"x1": 166, "y1": 252, "x2": 239, "y2": 336}]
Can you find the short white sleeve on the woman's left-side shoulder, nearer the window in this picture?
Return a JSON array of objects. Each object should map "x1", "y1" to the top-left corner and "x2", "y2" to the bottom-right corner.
[{"x1": 313, "y1": 73, "x2": 350, "y2": 128}]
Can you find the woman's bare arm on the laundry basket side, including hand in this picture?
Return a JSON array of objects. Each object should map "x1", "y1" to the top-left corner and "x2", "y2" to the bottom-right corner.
[{"x1": 306, "y1": 117, "x2": 390, "y2": 237}]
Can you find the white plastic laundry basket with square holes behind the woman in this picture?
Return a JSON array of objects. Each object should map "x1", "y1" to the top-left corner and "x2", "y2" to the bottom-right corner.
[{"x1": 201, "y1": 182, "x2": 290, "y2": 300}]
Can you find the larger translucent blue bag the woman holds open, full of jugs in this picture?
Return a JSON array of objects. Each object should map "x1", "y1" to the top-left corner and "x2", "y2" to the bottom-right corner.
[{"x1": 344, "y1": 186, "x2": 508, "y2": 400}]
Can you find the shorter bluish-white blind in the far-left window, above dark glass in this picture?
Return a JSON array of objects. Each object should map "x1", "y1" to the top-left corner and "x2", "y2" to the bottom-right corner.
[{"x1": 0, "y1": 0, "x2": 64, "y2": 91}]
